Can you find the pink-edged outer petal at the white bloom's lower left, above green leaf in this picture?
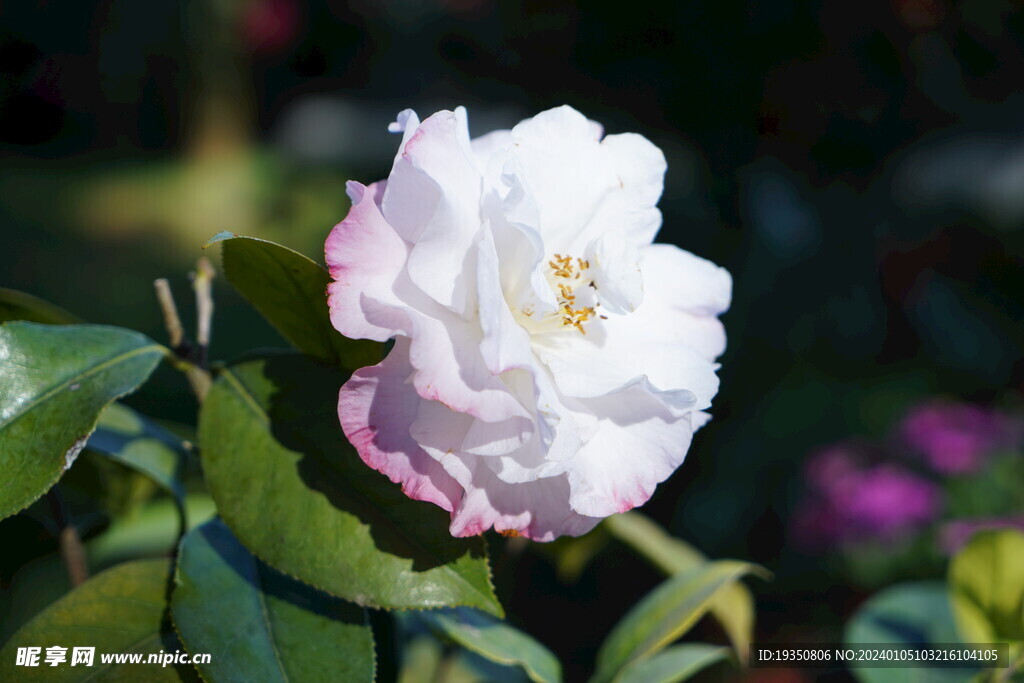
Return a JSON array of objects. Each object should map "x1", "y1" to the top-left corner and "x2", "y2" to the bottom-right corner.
[{"x1": 338, "y1": 339, "x2": 463, "y2": 512}]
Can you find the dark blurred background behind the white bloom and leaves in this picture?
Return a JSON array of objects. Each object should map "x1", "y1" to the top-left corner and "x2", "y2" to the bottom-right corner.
[{"x1": 0, "y1": 0, "x2": 1024, "y2": 680}]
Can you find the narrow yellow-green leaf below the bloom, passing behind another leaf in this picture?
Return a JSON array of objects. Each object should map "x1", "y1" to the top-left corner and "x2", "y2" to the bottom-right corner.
[{"x1": 603, "y1": 511, "x2": 755, "y2": 663}]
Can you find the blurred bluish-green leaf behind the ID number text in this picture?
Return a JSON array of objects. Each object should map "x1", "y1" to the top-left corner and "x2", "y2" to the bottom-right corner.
[{"x1": 844, "y1": 582, "x2": 973, "y2": 683}]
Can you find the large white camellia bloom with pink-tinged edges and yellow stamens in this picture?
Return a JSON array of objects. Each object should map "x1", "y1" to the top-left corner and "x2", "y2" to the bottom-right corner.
[{"x1": 327, "y1": 106, "x2": 731, "y2": 541}]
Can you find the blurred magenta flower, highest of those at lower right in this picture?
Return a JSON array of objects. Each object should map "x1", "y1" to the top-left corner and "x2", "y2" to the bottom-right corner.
[{"x1": 900, "y1": 401, "x2": 1009, "y2": 474}]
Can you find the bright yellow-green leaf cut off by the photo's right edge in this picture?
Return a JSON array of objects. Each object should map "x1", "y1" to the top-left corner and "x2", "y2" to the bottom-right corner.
[{"x1": 949, "y1": 528, "x2": 1024, "y2": 643}]
